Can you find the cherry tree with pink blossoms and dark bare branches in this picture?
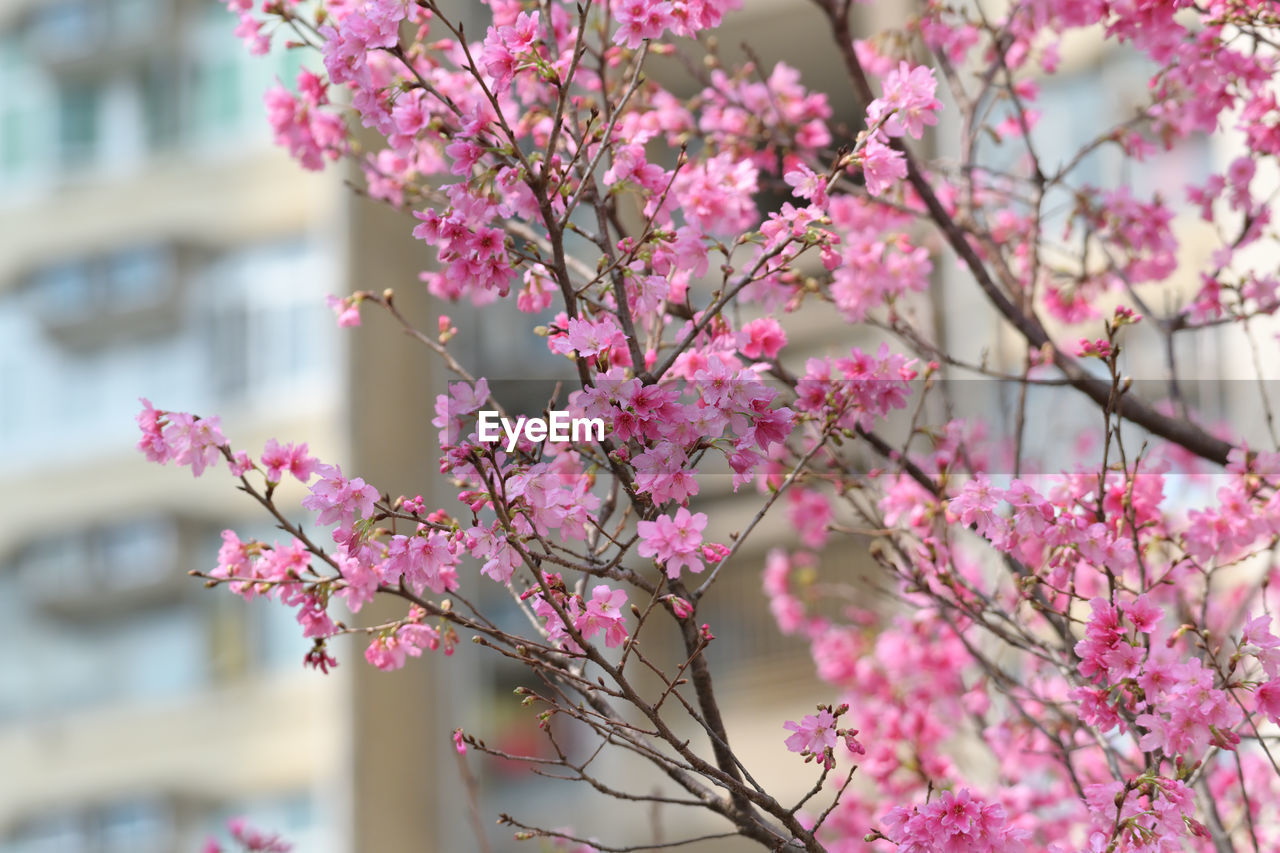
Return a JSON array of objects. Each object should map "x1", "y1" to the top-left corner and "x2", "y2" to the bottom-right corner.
[{"x1": 147, "y1": 0, "x2": 1280, "y2": 853}]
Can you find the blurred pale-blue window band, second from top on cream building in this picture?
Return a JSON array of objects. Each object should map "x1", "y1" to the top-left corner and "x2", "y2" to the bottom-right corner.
[{"x1": 0, "y1": 239, "x2": 340, "y2": 471}]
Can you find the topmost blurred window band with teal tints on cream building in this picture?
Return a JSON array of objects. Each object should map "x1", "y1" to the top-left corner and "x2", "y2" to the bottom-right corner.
[{"x1": 0, "y1": 0, "x2": 267, "y2": 185}]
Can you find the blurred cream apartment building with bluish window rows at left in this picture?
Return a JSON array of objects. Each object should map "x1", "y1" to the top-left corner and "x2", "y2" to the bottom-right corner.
[{"x1": 0, "y1": 0, "x2": 412, "y2": 853}]
